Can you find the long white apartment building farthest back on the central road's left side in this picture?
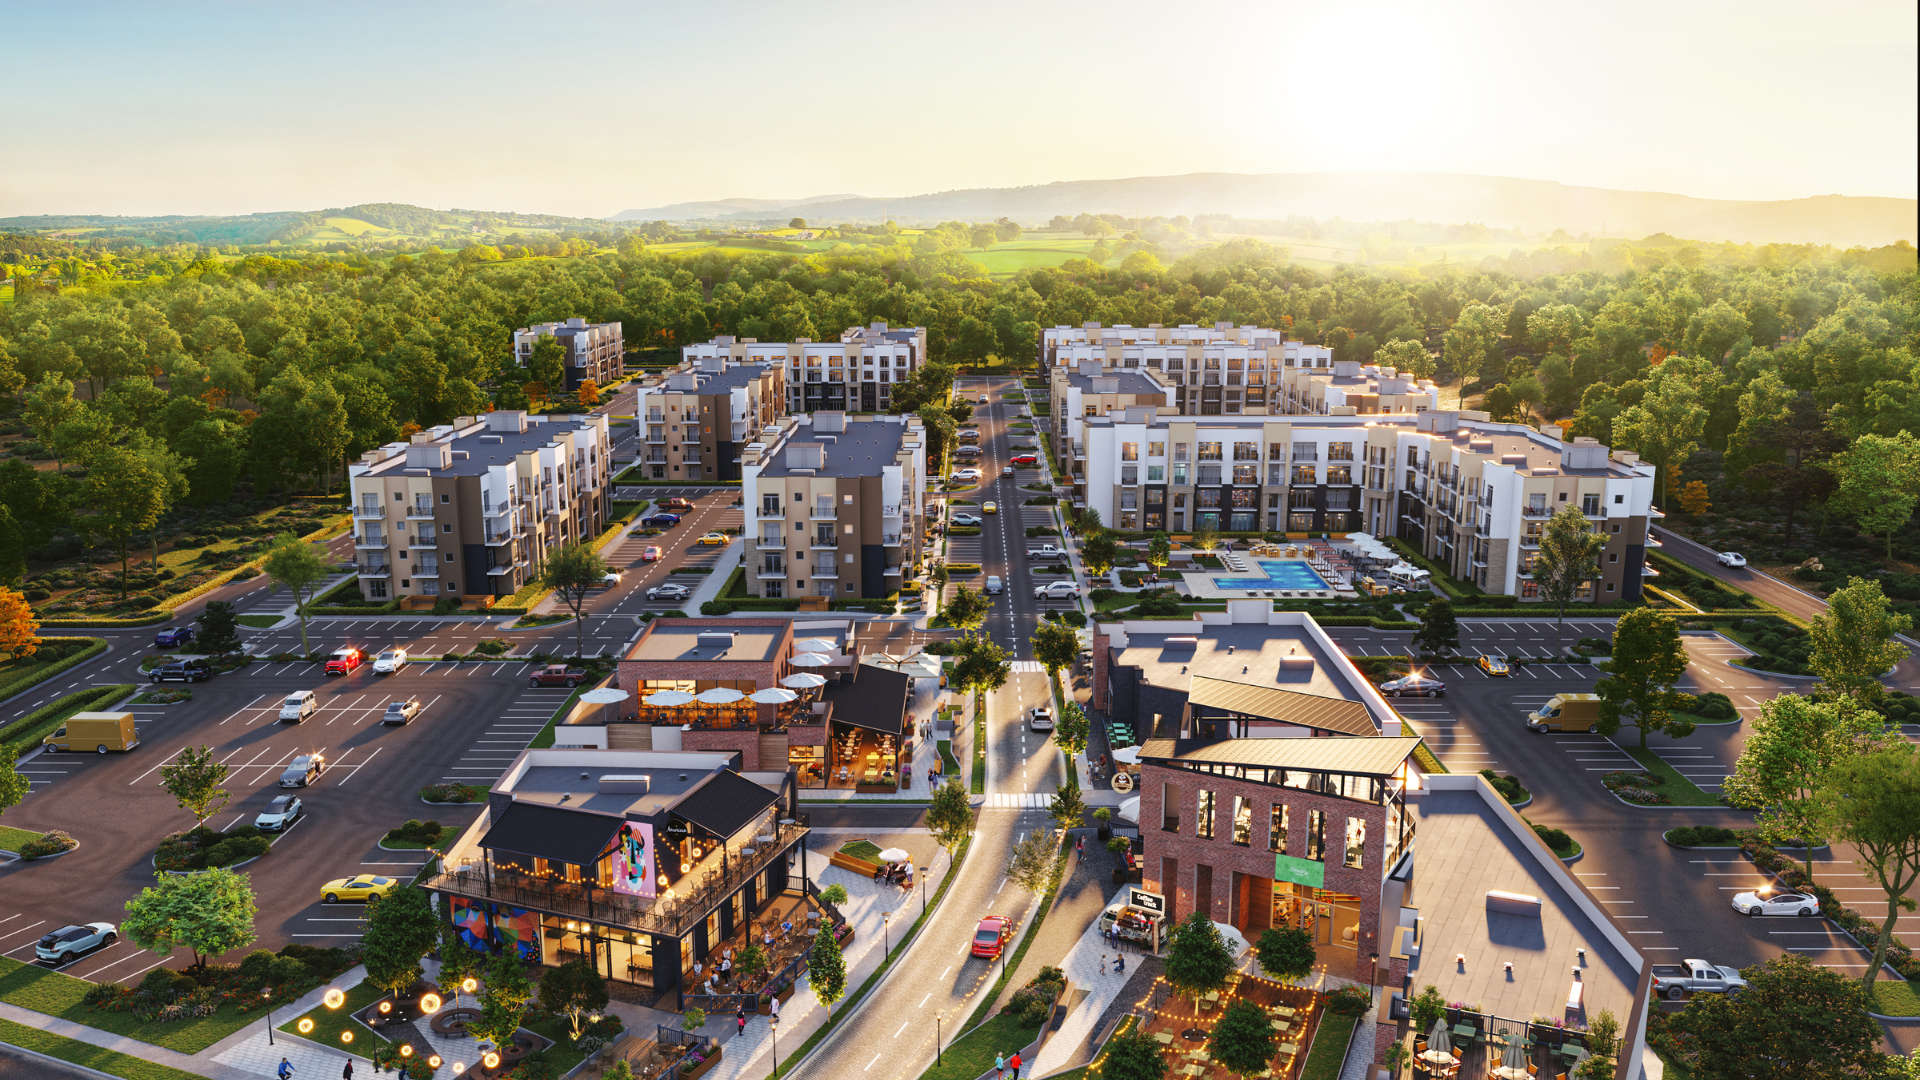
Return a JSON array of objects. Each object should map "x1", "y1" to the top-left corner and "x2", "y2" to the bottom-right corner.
[{"x1": 680, "y1": 323, "x2": 927, "y2": 413}]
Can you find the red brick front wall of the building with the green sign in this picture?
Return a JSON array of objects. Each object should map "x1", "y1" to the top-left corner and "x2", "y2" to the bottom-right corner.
[{"x1": 1140, "y1": 765, "x2": 1386, "y2": 980}]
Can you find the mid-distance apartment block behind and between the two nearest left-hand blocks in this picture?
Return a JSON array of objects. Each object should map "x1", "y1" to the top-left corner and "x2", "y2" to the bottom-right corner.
[{"x1": 634, "y1": 356, "x2": 787, "y2": 480}]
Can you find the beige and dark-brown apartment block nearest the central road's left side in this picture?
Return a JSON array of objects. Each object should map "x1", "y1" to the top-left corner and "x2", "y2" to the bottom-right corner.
[{"x1": 741, "y1": 409, "x2": 927, "y2": 600}]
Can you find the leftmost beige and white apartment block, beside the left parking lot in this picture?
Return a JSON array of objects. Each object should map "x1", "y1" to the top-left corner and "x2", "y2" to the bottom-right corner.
[{"x1": 348, "y1": 411, "x2": 609, "y2": 600}]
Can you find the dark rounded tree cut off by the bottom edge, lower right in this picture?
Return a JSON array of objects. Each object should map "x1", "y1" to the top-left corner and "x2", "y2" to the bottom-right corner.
[{"x1": 1668, "y1": 953, "x2": 1884, "y2": 1080}]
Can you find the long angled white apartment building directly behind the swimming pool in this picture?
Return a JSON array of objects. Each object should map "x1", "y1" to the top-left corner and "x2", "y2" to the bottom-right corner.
[{"x1": 1068, "y1": 407, "x2": 1663, "y2": 600}]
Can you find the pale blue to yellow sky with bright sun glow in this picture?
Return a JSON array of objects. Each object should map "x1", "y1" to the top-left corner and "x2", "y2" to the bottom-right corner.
[{"x1": 0, "y1": 0, "x2": 1920, "y2": 217}]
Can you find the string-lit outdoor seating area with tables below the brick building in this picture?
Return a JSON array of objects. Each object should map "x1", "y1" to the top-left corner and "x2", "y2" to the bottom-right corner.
[{"x1": 1133, "y1": 974, "x2": 1327, "y2": 1080}]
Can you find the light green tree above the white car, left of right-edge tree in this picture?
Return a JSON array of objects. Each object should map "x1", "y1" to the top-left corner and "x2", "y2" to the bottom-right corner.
[{"x1": 1724, "y1": 694, "x2": 1884, "y2": 880}]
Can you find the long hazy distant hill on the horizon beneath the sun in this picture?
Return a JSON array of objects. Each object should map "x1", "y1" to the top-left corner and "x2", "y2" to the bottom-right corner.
[{"x1": 614, "y1": 173, "x2": 1920, "y2": 248}]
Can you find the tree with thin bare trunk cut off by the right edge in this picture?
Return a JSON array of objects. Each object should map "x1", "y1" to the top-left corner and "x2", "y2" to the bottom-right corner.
[{"x1": 1828, "y1": 740, "x2": 1920, "y2": 995}]
